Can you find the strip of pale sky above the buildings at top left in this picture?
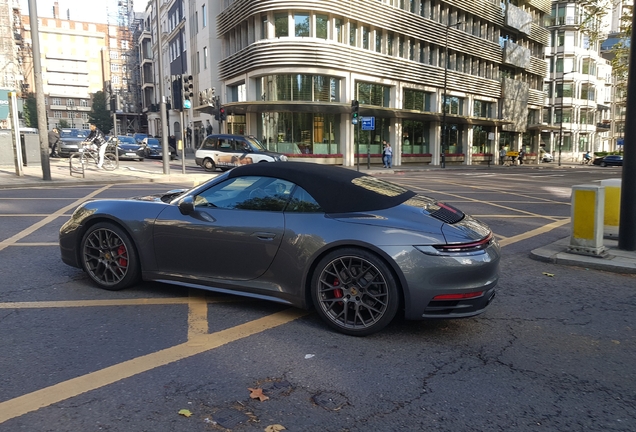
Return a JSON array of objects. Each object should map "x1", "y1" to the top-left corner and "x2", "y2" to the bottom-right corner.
[{"x1": 20, "y1": 0, "x2": 148, "y2": 23}]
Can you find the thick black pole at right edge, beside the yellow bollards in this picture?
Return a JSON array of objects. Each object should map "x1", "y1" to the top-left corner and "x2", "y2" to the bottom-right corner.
[{"x1": 618, "y1": 7, "x2": 636, "y2": 251}]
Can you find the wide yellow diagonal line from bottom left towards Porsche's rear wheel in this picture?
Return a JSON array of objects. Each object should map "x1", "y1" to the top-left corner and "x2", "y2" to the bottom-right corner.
[{"x1": 0, "y1": 309, "x2": 309, "y2": 423}]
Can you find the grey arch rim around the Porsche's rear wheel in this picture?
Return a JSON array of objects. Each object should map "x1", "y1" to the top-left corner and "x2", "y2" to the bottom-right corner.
[{"x1": 303, "y1": 242, "x2": 407, "y2": 311}]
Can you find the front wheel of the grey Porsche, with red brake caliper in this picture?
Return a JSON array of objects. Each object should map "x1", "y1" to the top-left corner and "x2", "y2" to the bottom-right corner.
[{"x1": 81, "y1": 222, "x2": 140, "y2": 291}]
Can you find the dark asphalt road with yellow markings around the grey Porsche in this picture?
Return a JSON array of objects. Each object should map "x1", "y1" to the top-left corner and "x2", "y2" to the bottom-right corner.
[{"x1": 0, "y1": 167, "x2": 636, "y2": 432}]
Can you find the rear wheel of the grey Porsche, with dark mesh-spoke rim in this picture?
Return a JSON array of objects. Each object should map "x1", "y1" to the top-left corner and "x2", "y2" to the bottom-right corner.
[{"x1": 311, "y1": 248, "x2": 400, "y2": 336}]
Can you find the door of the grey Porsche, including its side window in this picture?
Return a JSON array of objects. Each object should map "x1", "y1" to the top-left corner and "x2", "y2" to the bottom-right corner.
[{"x1": 154, "y1": 177, "x2": 292, "y2": 280}]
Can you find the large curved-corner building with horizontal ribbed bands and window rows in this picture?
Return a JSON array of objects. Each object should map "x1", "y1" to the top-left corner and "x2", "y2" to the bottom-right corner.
[{"x1": 189, "y1": 0, "x2": 550, "y2": 166}]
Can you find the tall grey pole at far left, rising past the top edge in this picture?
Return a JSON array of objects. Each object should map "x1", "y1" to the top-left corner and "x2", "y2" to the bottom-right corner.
[{"x1": 27, "y1": 0, "x2": 51, "y2": 180}]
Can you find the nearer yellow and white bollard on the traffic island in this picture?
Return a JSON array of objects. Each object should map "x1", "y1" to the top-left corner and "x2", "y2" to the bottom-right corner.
[{"x1": 568, "y1": 185, "x2": 607, "y2": 257}]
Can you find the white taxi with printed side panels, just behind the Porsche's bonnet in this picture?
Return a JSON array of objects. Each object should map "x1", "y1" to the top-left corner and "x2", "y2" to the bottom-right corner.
[{"x1": 194, "y1": 134, "x2": 287, "y2": 171}]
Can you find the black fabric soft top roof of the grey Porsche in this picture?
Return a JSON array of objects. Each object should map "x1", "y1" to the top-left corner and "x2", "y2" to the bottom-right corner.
[{"x1": 228, "y1": 162, "x2": 415, "y2": 213}]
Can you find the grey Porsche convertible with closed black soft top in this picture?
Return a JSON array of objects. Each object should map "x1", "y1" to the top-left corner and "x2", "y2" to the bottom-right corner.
[{"x1": 60, "y1": 162, "x2": 500, "y2": 336}]
